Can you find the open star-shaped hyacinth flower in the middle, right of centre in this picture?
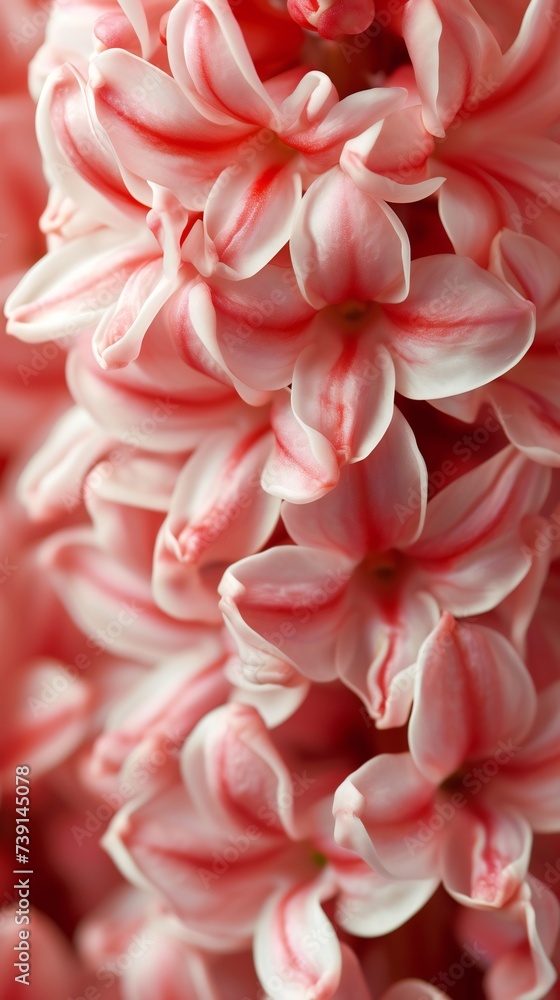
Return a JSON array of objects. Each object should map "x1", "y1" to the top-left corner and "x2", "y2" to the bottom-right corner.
[{"x1": 220, "y1": 411, "x2": 549, "y2": 726}]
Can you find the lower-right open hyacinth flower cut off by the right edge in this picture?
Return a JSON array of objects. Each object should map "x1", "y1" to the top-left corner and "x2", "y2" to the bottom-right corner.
[{"x1": 334, "y1": 616, "x2": 560, "y2": 908}]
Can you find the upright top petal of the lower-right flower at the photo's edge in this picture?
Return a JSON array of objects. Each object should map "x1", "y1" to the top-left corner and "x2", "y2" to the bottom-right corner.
[{"x1": 409, "y1": 614, "x2": 536, "y2": 784}]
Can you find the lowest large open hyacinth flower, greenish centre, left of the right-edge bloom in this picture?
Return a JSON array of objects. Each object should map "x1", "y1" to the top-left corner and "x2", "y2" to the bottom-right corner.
[{"x1": 106, "y1": 705, "x2": 446, "y2": 998}]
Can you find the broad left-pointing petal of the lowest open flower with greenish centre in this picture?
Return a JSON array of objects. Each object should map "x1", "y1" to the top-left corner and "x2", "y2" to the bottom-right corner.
[{"x1": 104, "y1": 784, "x2": 290, "y2": 951}]
